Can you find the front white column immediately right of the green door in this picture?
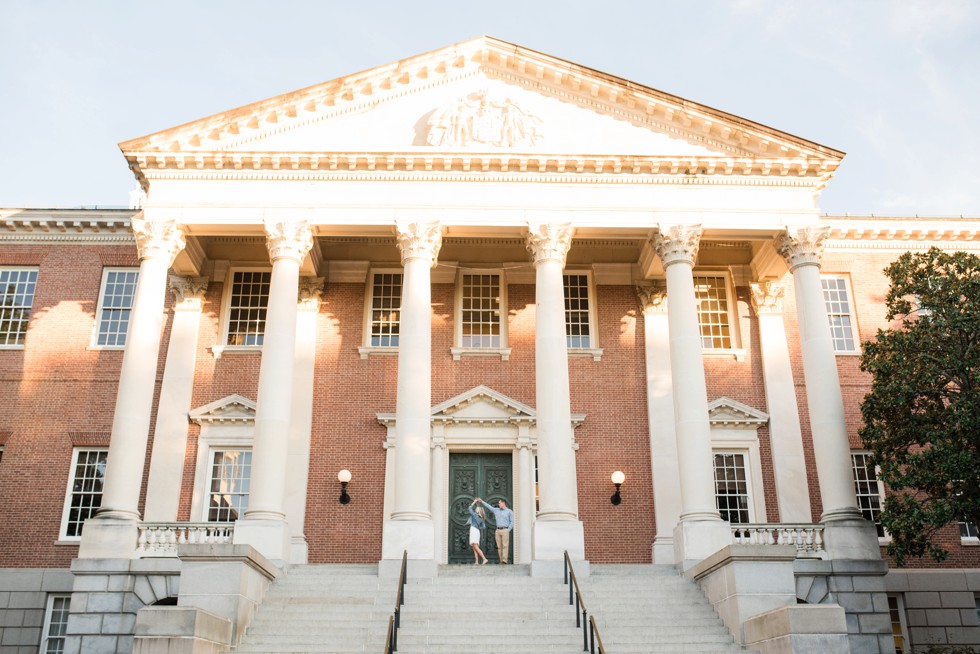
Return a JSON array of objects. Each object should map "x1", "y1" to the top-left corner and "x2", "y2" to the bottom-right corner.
[{"x1": 527, "y1": 224, "x2": 585, "y2": 572}]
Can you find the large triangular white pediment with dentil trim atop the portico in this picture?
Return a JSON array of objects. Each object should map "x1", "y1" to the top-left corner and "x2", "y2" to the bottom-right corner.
[{"x1": 121, "y1": 37, "x2": 842, "y2": 179}]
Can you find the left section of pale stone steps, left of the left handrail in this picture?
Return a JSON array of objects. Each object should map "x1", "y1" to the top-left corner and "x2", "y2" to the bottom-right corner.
[{"x1": 235, "y1": 565, "x2": 398, "y2": 654}]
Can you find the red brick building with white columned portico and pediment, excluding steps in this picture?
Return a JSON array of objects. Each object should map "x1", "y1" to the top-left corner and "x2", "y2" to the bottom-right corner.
[{"x1": 0, "y1": 38, "x2": 980, "y2": 652}]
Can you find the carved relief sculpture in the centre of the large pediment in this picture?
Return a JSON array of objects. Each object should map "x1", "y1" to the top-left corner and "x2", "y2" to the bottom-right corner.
[{"x1": 426, "y1": 91, "x2": 541, "y2": 147}]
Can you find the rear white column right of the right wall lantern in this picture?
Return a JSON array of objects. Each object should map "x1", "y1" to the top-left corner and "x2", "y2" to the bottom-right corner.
[{"x1": 636, "y1": 282, "x2": 681, "y2": 564}]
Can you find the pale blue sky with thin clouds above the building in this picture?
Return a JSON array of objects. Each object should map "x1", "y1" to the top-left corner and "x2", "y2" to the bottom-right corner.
[{"x1": 0, "y1": 0, "x2": 980, "y2": 217}]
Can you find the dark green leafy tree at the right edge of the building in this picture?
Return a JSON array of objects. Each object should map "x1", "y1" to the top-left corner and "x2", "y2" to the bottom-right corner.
[{"x1": 860, "y1": 248, "x2": 980, "y2": 565}]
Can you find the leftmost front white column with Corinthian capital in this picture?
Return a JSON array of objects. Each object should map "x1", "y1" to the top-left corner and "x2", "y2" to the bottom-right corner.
[{"x1": 78, "y1": 214, "x2": 184, "y2": 558}]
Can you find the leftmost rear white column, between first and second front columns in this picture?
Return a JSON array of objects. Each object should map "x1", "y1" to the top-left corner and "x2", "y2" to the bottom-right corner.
[{"x1": 144, "y1": 275, "x2": 208, "y2": 522}]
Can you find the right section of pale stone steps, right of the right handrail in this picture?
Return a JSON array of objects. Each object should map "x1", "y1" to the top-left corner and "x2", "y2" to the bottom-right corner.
[{"x1": 579, "y1": 564, "x2": 755, "y2": 654}]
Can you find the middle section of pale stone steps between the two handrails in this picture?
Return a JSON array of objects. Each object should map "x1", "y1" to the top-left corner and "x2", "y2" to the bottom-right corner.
[{"x1": 398, "y1": 565, "x2": 582, "y2": 654}]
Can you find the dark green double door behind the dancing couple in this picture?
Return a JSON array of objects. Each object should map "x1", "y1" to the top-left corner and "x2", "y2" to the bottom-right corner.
[{"x1": 449, "y1": 453, "x2": 514, "y2": 563}]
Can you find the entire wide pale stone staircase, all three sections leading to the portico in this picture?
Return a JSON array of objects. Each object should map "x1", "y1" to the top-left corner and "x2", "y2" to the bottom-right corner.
[{"x1": 235, "y1": 565, "x2": 756, "y2": 654}]
